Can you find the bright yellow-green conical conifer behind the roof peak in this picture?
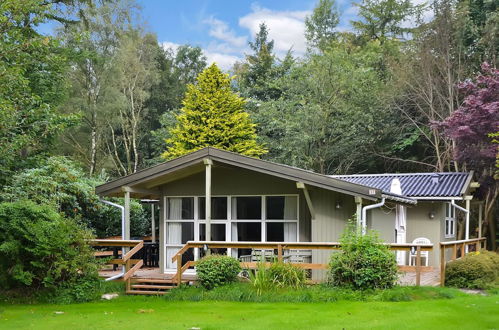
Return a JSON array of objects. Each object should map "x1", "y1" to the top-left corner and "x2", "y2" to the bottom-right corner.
[{"x1": 162, "y1": 64, "x2": 267, "y2": 159}]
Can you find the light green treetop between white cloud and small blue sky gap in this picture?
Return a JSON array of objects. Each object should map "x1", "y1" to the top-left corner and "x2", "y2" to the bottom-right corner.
[{"x1": 305, "y1": 0, "x2": 340, "y2": 50}]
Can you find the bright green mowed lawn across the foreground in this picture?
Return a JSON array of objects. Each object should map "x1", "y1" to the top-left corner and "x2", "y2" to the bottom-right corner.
[{"x1": 0, "y1": 295, "x2": 499, "y2": 330}]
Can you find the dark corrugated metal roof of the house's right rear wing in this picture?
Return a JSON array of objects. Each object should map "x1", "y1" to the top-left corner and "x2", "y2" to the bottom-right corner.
[{"x1": 331, "y1": 172, "x2": 473, "y2": 199}]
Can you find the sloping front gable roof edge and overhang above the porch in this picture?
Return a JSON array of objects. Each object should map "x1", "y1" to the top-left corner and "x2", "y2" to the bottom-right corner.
[{"x1": 95, "y1": 147, "x2": 416, "y2": 204}]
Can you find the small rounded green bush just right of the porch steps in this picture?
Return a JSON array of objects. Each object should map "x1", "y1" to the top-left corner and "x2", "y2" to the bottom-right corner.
[{"x1": 196, "y1": 254, "x2": 241, "y2": 289}]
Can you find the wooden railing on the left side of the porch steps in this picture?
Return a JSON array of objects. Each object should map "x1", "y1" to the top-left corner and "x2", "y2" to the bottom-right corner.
[{"x1": 90, "y1": 239, "x2": 144, "y2": 291}]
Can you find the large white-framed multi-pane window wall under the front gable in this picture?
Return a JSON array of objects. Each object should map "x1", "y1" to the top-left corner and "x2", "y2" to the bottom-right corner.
[{"x1": 165, "y1": 195, "x2": 299, "y2": 269}]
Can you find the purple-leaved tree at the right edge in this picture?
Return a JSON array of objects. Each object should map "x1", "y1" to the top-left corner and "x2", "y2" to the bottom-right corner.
[{"x1": 433, "y1": 63, "x2": 499, "y2": 250}]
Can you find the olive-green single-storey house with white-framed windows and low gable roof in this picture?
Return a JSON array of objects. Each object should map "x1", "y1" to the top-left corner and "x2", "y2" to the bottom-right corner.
[{"x1": 96, "y1": 147, "x2": 482, "y2": 277}]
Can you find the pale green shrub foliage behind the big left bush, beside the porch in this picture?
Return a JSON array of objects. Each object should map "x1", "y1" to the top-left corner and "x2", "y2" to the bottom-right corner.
[{"x1": 1, "y1": 157, "x2": 149, "y2": 237}]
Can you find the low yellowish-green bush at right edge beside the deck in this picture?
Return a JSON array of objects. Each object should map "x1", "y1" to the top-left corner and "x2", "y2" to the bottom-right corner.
[{"x1": 445, "y1": 251, "x2": 499, "y2": 289}]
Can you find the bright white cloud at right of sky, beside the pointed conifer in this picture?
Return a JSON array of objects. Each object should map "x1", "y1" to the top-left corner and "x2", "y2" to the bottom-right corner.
[{"x1": 239, "y1": 6, "x2": 310, "y2": 55}]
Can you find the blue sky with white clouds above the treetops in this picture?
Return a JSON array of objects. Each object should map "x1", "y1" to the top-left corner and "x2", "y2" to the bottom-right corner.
[{"x1": 138, "y1": 0, "x2": 357, "y2": 70}]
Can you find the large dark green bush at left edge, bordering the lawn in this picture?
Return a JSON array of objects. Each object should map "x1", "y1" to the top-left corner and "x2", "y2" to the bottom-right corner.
[{"x1": 0, "y1": 201, "x2": 99, "y2": 301}]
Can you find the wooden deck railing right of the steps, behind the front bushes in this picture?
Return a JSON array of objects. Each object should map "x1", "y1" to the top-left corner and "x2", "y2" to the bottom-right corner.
[{"x1": 172, "y1": 241, "x2": 433, "y2": 285}]
